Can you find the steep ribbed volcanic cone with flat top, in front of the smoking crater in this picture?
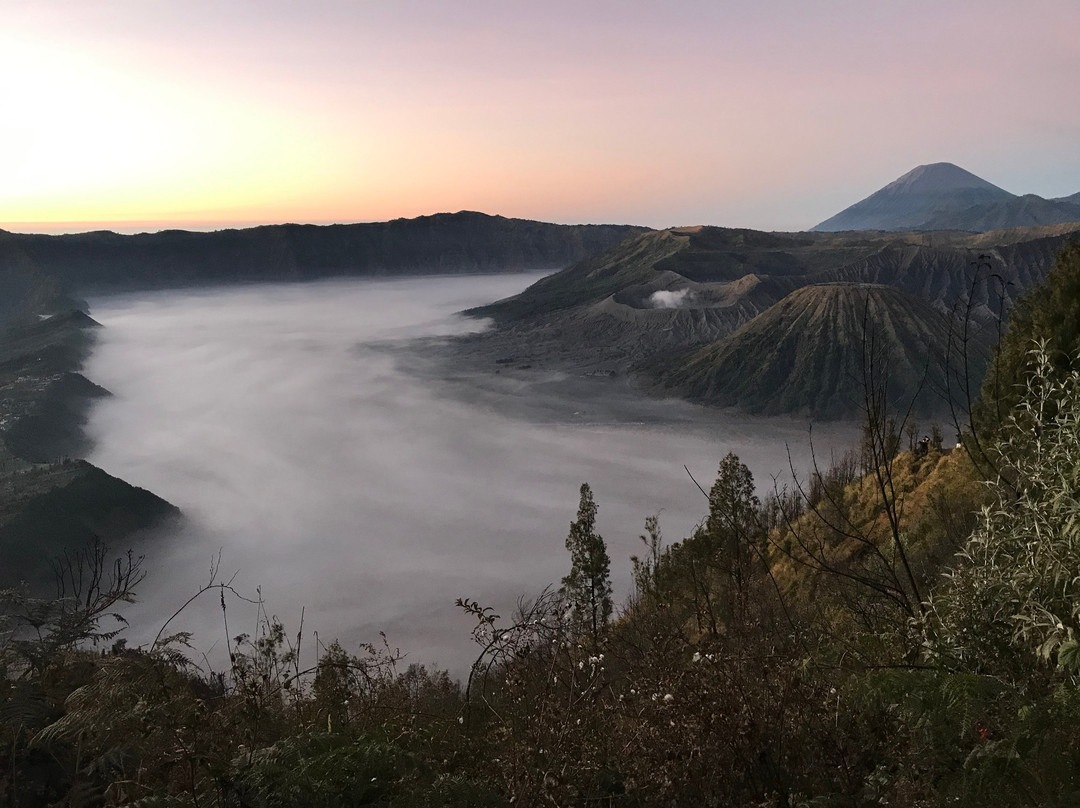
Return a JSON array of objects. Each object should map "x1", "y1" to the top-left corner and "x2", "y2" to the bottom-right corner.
[{"x1": 658, "y1": 284, "x2": 972, "y2": 418}]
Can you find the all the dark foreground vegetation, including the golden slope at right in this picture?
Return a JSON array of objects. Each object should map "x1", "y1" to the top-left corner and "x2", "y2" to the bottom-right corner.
[{"x1": 6, "y1": 250, "x2": 1080, "y2": 808}]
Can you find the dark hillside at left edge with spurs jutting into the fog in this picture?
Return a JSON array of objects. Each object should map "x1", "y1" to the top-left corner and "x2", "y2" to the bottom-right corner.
[{"x1": 0, "y1": 306, "x2": 178, "y2": 588}]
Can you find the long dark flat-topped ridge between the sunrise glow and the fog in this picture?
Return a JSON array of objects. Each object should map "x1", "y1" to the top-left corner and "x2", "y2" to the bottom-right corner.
[{"x1": 0, "y1": 212, "x2": 646, "y2": 289}]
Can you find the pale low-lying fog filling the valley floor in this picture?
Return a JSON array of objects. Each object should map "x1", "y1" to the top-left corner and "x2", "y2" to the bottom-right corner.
[{"x1": 85, "y1": 274, "x2": 852, "y2": 674}]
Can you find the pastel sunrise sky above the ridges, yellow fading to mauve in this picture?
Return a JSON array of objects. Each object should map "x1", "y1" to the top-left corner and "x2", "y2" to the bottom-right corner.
[{"x1": 0, "y1": 0, "x2": 1080, "y2": 232}]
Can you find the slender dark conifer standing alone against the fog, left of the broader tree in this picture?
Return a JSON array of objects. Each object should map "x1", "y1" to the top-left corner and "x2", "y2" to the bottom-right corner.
[{"x1": 563, "y1": 483, "x2": 611, "y2": 645}]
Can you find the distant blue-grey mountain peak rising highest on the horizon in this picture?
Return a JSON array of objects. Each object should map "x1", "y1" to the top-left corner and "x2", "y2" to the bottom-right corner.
[{"x1": 811, "y1": 163, "x2": 1014, "y2": 232}]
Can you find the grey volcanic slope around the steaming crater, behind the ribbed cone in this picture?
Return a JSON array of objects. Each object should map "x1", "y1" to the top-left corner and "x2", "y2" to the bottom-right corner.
[{"x1": 457, "y1": 227, "x2": 924, "y2": 375}]
